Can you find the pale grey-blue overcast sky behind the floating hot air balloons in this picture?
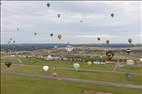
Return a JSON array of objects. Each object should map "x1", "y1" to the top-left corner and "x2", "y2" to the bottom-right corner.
[{"x1": 1, "y1": 1, "x2": 142, "y2": 43}]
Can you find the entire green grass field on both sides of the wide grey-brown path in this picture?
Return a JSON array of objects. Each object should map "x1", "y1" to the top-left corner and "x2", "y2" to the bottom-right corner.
[{"x1": 1, "y1": 55, "x2": 142, "y2": 94}]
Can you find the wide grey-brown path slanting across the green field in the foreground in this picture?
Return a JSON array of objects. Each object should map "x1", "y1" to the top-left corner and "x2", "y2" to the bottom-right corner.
[{"x1": 1, "y1": 72, "x2": 142, "y2": 89}]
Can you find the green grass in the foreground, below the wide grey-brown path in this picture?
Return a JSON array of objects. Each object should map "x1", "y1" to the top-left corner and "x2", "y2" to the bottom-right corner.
[{"x1": 1, "y1": 76, "x2": 141, "y2": 94}]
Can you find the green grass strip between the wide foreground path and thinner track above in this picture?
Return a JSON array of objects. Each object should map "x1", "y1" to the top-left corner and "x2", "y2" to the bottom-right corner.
[{"x1": 1, "y1": 65, "x2": 142, "y2": 84}]
